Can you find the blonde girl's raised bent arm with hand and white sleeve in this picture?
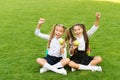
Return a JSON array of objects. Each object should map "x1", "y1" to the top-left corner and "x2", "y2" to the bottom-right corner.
[{"x1": 35, "y1": 18, "x2": 50, "y2": 40}]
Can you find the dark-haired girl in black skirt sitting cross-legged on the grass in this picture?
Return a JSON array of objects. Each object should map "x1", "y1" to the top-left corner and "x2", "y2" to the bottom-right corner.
[{"x1": 69, "y1": 12, "x2": 102, "y2": 71}]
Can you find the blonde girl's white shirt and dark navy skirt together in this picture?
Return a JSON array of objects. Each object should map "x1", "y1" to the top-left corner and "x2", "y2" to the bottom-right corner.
[{"x1": 35, "y1": 29, "x2": 66, "y2": 65}]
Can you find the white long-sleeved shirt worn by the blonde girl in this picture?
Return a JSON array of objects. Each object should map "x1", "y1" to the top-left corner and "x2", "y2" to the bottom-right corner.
[{"x1": 35, "y1": 29, "x2": 67, "y2": 58}]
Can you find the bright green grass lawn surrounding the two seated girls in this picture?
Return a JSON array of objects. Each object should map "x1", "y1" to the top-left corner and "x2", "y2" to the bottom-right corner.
[{"x1": 0, "y1": 0, "x2": 120, "y2": 80}]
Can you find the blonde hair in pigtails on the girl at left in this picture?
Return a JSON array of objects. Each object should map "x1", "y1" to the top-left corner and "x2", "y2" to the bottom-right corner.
[{"x1": 48, "y1": 24, "x2": 66, "y2": 48}]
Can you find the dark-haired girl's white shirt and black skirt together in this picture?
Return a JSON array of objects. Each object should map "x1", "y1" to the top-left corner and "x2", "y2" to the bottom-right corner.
[{"x1": 70, "y1": 25, "x2": 98, "y2": 65}]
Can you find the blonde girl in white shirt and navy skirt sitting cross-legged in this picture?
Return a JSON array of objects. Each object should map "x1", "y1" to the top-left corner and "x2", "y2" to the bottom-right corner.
[{"x1": 35, "y1": 18, "x2": 70, "y2": 75}]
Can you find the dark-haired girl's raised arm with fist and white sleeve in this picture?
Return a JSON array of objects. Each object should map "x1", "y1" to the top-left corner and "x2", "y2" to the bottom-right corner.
[{"x1": 87, "y1": 12, "x2": 101, "y2": 37}]
